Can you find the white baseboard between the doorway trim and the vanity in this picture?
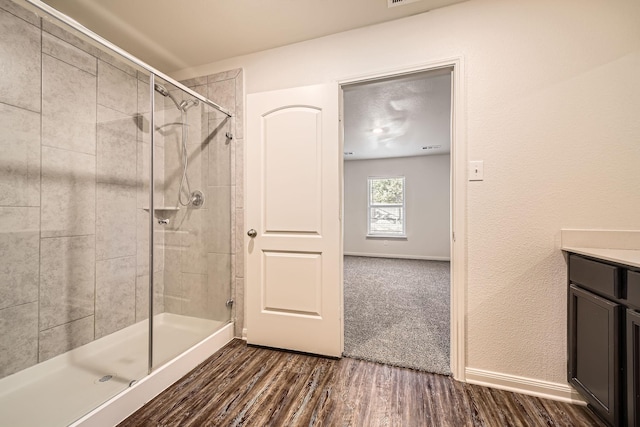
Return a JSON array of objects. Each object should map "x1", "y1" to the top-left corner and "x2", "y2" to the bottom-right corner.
[{"x1": 465, "y1": 368, "x2": 586, "y2": 405}]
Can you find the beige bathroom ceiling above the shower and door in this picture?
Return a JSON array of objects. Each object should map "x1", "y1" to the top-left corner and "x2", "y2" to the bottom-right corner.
[{"x1": 44, "y1": 0, "x2": 464, "y2": 74}]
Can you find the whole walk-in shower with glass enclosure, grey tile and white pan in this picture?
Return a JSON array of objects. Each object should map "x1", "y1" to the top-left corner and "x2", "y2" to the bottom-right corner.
[{"x1": 0, "y1": 0, "x2": 235, "y2": 426}]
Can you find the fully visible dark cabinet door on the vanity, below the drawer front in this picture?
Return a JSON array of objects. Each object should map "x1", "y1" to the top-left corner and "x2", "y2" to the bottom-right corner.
[{"x1": 568, "y1": 285, "x2": 624, "y2": 425}]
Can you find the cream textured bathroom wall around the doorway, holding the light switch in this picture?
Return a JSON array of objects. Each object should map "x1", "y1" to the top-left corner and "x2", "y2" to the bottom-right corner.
[{"x1": 177, "y1": 0, "x2": 640, "y2": 384}]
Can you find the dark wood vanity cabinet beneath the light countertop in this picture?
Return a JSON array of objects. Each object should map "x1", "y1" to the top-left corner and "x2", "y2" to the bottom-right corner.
[{"x1": 567, "y1": 254, "x2": 640, "y2": 427}]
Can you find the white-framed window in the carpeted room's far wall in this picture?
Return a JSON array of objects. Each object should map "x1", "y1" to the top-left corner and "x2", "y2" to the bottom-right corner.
[{"x1": 368, "y1": 177, "x2": 405, "y2": 237}]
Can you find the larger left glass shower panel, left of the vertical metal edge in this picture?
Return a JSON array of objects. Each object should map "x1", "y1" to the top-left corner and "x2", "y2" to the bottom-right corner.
[{"x1": 0, "y1": 1, "x2": 150, "y2": 426}]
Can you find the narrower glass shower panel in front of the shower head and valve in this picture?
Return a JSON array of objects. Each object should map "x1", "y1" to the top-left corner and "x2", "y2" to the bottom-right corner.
[{"x1": 153, "y1": 78, "x2": 231, "y2": 367}]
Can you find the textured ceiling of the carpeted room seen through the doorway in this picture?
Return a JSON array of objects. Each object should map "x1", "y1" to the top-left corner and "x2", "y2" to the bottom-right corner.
[{"x1": 343, "y1": 69, "x2": 451, "y2": 160}]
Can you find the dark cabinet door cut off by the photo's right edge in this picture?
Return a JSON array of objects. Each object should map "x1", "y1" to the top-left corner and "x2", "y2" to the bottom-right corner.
[{"x1": 627, "y1": 310, "x2": 640, "y2": 426}]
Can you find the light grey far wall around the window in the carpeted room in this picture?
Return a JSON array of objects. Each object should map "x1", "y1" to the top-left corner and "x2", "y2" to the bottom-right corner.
[{"x1": 344, "y1": 154, "x2": 450, "y2": 260}]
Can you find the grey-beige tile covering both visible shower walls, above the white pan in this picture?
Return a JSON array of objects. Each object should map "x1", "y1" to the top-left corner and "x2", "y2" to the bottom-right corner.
[{"x1": 0, "y1": 0, "x2": 244, "y2": 378}]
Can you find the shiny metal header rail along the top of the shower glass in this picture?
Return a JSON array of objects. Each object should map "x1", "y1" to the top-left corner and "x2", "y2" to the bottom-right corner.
[{"x1": 24, "y1": 0, "x2": 233, "y2": 117}]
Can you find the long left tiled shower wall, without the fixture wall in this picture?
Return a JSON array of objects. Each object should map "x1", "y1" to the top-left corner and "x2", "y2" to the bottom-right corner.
[{"x1": 0, "y1": 0, "x2": 170, "y2": 377}]
